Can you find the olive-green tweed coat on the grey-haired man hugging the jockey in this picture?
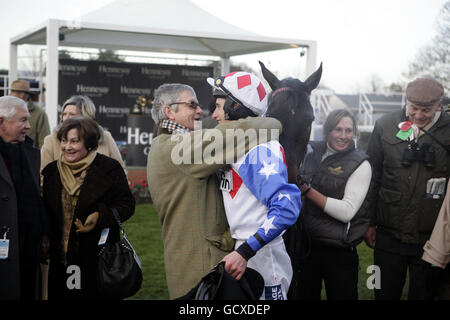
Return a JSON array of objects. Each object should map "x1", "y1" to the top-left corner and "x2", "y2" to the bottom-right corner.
[{"x1": 147, "y1": 118, "x2": 281, "y2": 299}]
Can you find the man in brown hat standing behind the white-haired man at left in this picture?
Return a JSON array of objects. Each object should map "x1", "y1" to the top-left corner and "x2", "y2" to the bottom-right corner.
[{"x1": 10, "y1": 79, "x2": 50, "y2": 149}]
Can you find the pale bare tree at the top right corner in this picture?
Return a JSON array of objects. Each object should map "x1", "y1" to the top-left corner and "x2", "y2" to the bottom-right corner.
[{"x1": 405, "y1": 1, "x2": 450, "y2": 91}]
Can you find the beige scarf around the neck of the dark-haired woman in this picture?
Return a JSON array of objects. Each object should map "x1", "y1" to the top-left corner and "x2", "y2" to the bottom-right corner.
[{"x1": 57, "y1": 151, "x2": 97, "y2": 196}]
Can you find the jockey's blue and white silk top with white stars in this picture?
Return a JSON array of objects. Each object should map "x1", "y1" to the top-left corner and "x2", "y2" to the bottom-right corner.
[{"x1": 221, "y1": 141, "x2": 301, "y2": 252}]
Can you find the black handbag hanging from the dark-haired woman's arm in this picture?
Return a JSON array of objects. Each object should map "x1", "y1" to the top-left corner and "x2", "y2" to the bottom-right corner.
[{"x1": 97, "y1": 208, "x2": 142, "y2": 299}]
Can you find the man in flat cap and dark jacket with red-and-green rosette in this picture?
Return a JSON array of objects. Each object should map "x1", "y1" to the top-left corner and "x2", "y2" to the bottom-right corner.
[{"x1": 366, "y1": 78, "x2": 450, "y2": 300}]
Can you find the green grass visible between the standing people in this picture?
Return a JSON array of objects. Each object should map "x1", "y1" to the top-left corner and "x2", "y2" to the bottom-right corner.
[{"x1": 124, "y1": 204, "x2": 408, "y2": 300}]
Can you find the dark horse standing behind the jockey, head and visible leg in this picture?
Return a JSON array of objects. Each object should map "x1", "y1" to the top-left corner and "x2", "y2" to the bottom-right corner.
[{"x1": 259, "y1": 61, "x2": 322, "y2": 299}]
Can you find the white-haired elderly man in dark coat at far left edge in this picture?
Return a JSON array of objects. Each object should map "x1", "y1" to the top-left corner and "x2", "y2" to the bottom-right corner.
[{"x1": 0, "y1": 96, "x2": 47, "y2": 300}]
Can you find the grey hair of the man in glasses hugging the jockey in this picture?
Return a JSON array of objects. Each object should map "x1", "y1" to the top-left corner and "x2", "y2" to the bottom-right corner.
[{"x1": 152, "y1": 83, "x2": 196, "y2": 124}]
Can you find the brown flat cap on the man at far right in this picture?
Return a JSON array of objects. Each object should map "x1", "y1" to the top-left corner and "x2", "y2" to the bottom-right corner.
[{"x1": 406, "y1": 77, "x2": 444, "y2": 107}]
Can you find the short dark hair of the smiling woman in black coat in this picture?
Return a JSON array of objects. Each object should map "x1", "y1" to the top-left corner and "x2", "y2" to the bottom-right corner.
[{"x1": 56, "y1": 117, "x2": 101, "y2": 151}]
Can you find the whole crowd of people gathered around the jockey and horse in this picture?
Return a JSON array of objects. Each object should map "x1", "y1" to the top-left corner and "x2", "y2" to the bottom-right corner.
[{"x1": 0, "y1": 71, "x2": 450, "y2": 300}]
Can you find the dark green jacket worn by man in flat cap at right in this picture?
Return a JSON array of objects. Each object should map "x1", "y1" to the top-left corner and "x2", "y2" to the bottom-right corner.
[{"x1": 367, "y1": 109, "x2": 450, "y2": 245}]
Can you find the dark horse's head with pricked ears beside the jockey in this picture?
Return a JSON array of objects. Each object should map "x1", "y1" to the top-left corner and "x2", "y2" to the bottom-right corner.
[{"x1": 259, "y1": 61, "x2": 322, "y2": 183}]
